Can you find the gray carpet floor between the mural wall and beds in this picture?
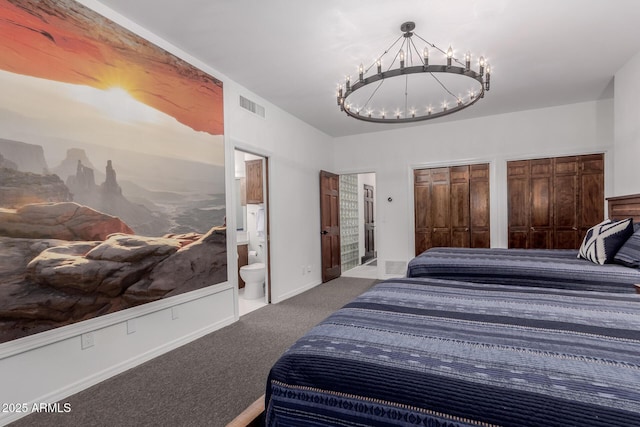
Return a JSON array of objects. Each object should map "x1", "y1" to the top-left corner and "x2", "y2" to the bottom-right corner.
[{"x1": 11, "y1": 277, "x2": 376, "y2": 427}]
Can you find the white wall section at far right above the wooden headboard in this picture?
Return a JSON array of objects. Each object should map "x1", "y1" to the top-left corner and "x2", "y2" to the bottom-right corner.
[{"x1": 611, "y1": 53, "x2": 640, "y2": 196}]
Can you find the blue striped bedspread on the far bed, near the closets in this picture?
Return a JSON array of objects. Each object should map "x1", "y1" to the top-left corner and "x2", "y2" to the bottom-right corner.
[{"x1": 407, "y1": 248, "x2": 640, "y2": 293}]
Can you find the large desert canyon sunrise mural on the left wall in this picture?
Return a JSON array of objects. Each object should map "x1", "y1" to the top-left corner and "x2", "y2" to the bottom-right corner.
[{"x1": 0, "y1": 0, "x2": 227, "y2": 343}]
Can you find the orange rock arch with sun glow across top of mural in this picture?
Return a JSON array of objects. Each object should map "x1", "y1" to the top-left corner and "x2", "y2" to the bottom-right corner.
[{"x1": 0, "y1": 0, "x2": 224, "y2": 135}]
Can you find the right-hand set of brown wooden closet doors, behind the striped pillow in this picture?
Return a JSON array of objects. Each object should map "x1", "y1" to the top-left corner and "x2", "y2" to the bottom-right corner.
[{"x1": 507, "y1": 154, "x2": 604, "y2": 249}]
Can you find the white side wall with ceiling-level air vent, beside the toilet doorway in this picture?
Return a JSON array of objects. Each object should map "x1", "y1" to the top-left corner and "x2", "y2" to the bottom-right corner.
[{"x1": 224, "y1": 83, "x2": 333, "y2": 303}]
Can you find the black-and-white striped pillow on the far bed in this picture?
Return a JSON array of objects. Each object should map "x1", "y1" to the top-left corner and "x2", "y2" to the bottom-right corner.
[{"x1": 578, "y1": 218, "x2": 633, "y2": 265}]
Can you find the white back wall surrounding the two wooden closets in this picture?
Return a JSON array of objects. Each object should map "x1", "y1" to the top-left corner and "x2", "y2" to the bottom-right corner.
[{"x1": 335, "y1": 99, "x2": 613, "y2": 279}]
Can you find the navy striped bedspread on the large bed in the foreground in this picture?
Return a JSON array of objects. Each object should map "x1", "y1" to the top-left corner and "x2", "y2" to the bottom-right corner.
[{"x1": 265, "y1": 278, "x2": 640, "y2": 427}]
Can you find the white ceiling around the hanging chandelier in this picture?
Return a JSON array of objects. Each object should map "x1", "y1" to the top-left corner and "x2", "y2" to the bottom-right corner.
[{"x1": 99, "y1": 0, "x2": 640, "y2": 136}]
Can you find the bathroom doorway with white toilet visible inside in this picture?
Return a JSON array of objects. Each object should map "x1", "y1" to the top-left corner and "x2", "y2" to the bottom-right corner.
[{"x1": 234, "y1": 149, "x2": 271, "y2": 316}]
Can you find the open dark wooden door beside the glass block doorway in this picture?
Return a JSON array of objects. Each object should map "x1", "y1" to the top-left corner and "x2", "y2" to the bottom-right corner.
[{"x1": 320, "y1": 171, "x2": 341, "y2": 283}]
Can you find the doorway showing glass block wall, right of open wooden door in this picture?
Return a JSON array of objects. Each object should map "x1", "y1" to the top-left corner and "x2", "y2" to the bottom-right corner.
[{"x1": 340, "y1": 173, "x2": 378, "y2": 279}]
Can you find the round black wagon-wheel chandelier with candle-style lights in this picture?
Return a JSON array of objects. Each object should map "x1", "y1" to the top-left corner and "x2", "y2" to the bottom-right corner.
[{"x1": 337, "y1": 21, "x2": 491, "y2": 123}]
